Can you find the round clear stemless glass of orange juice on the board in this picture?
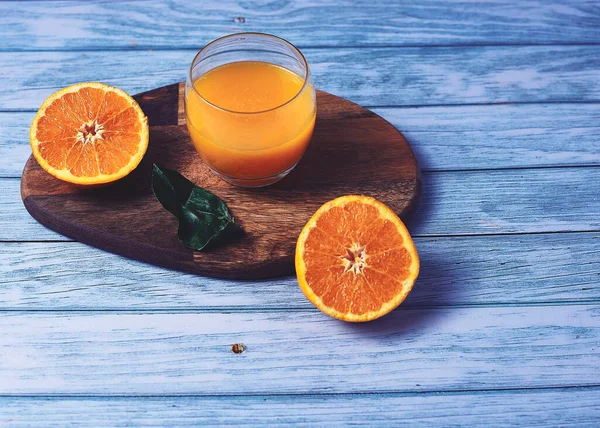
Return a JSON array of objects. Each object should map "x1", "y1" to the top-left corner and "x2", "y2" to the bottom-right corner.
[{"x1": 185, "y1": 33, "x2": 317, "y2": 187}]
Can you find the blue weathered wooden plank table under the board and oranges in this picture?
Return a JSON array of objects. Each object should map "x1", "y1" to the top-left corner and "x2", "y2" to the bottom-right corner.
[{"x1": 0, "y1": 0, "x2": 600, "y2": 427}]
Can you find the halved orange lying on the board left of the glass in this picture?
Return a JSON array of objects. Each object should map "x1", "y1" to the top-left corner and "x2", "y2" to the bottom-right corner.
[{"x1": 29, "y1": 82, "x2": 148, "y2": 185}]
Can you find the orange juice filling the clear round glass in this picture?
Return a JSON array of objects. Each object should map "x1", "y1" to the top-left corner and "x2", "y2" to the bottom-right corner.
[{"x1": 186, "y1": 61, "x2": 316, "y2": 185}]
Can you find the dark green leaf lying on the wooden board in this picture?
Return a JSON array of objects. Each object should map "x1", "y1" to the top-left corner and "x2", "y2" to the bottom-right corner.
[{"x1": 152, "y1": 165, "x2": 239, "y2": 251}]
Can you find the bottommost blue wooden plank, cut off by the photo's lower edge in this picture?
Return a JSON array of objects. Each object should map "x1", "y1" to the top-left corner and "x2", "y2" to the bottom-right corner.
[{"x1": 0, "y1": 387, "x2": 600, "y2": 427}]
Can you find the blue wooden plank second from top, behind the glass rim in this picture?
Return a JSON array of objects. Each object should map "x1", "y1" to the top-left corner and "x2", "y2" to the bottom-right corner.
[{"x1": 0, "y1": 46, "x2": 600, "y2": 110}]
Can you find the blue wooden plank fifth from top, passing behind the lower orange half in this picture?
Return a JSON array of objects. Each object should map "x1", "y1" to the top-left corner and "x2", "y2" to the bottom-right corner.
[{"x1": 0, "y1": 233, "x2": 600, "y2": 312}]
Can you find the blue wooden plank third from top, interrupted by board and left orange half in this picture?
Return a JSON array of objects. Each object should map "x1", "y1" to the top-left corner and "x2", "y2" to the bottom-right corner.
[{"x1": 0, "y1": 104, "x2": 600, "y2": 177}]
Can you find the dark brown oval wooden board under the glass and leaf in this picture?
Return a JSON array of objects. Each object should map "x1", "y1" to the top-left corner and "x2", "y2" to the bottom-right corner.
[{"x1": 21, "y1": 83, "x2": 421, "y2": 279}]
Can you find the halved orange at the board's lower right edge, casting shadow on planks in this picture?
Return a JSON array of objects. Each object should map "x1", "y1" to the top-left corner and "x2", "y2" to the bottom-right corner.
[{"x1": 296, "y1": 196, "x2": 419, "y2": 322}]
